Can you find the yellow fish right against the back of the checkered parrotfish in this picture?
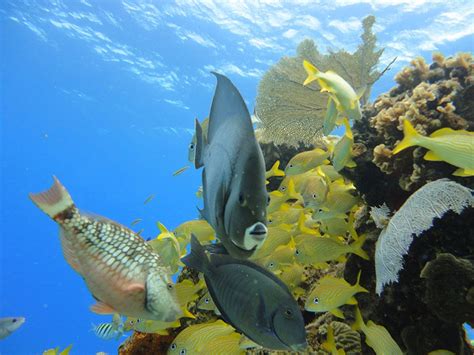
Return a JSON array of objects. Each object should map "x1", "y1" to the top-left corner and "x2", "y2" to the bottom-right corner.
[{"x1": 148, "y1": 222, "x2": 186, "y2": 273}]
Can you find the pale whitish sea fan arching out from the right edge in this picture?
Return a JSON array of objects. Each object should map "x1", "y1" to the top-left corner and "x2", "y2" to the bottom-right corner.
[{"x1": 375, "y1": 179, "x2": 474, "y2": 294}]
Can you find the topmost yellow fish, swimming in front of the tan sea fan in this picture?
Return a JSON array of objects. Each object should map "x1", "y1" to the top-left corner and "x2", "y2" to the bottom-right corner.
[{"x1": 303, "y1": 60, "x2": 363, "y2": 120}]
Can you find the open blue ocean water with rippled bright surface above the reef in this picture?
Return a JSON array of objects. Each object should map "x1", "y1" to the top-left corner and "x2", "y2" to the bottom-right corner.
[{"x1": 0, "y1": 0, "x2": 474, "y2": 354}]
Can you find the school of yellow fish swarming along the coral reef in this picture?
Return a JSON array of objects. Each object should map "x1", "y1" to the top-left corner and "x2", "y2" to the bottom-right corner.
[{"x1": 36, "y1": 61, "x2": 473, "y2": 354}]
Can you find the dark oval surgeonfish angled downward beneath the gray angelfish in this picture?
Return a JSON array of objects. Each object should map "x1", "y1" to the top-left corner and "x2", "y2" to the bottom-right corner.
[{"x1": 182, "y1": 235, "x2": 307, "y2": 351}]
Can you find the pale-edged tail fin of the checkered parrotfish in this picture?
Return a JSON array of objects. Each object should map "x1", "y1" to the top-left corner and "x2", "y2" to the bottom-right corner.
[{"x1": 29, "y1": 176, "x2": 74, "y2": 218}]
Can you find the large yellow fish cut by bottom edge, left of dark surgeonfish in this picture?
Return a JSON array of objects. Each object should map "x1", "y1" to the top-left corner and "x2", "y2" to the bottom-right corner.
[{"x1": 168, "y1": 320, "x2": 235, "y2": 355}]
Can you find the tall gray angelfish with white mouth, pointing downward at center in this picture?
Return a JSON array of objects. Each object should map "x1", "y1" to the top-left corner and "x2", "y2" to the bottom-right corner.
[{"x1": 194, "y1": 73, "x2": 268, "y2": 259}]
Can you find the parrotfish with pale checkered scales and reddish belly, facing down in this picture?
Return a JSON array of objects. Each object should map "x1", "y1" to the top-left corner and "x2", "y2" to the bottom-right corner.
[{"x1": 30, "y1": 177, "x2": 180, "y2": 320}]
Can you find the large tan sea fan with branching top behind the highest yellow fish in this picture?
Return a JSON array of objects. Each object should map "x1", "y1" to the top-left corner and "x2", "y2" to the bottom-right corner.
[{"x1": 256, "y1": 16, "x2": 383, "y2": 146}]
